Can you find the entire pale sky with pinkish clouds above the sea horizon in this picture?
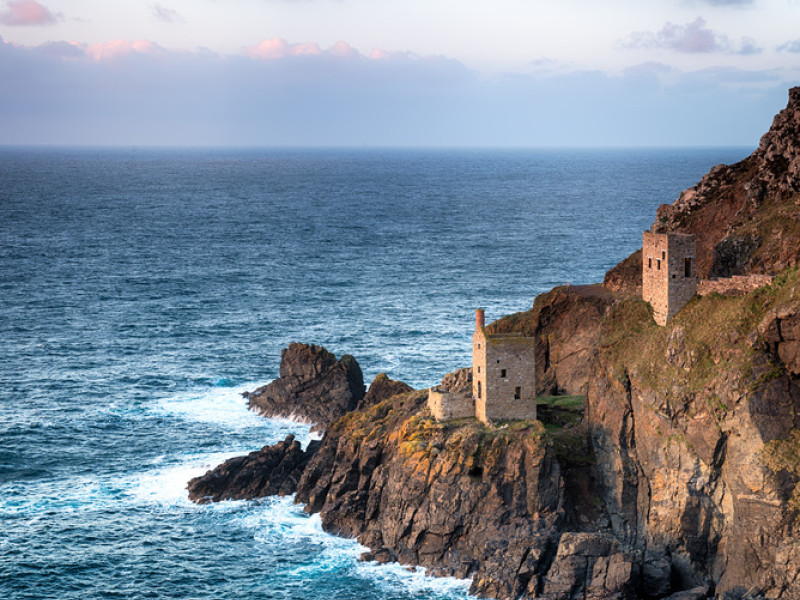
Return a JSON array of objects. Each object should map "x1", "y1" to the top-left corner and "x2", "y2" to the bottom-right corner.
[{"x1": 0, "y1": 0, "x2": 800, "y2": 147}]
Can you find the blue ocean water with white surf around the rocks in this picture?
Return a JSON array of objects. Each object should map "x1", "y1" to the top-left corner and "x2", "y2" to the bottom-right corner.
[{"x1": 0, "y1": 148, "x2": 751, "y2": 600}]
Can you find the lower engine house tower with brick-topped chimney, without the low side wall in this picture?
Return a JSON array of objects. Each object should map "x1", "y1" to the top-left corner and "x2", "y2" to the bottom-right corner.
[{"x1": 472, "y1": 309, "x2": 536, "y2": 423}]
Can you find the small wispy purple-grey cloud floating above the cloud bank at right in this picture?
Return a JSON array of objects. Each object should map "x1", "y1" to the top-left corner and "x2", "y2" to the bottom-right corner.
[{"x1": 622, "y1": 17, "x2": 762, "y2": 55}]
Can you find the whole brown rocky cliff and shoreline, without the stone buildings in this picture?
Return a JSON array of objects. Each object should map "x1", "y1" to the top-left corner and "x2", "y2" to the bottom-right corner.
[{"x1": 189, "y1": 88, "x2": 800, "y2": 600}]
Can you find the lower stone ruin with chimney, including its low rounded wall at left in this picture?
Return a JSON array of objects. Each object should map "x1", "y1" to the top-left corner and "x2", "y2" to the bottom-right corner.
[{"x1": 428, "y1": 309, "x2": 536, "y2": 424}]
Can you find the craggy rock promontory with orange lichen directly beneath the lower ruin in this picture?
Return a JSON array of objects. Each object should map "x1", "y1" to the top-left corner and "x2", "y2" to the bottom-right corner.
[{"x1": 297, "y1": 392, "x2": 563, "y2": 598}]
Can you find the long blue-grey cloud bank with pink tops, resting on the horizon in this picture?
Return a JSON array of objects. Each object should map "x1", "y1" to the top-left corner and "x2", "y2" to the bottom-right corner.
[{"x1": 0, "y1": 39, "x2": 791, "y2": 146}]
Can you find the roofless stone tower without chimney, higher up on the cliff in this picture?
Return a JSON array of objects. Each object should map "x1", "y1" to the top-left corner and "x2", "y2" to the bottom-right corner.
[{"x1": 642, "y1": 231, "x2": 697, "y2": 325}]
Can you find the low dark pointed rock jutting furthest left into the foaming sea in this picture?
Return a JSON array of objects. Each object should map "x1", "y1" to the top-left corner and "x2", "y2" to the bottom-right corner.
[{"x1": 187, "y1": 435, "x2": 319, "y2": 504}]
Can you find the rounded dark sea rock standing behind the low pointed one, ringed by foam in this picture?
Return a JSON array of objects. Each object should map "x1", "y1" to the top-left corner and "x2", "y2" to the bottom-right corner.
[{"x1": 245, "y1": 343, "x2": 364, "y2": 428}]
